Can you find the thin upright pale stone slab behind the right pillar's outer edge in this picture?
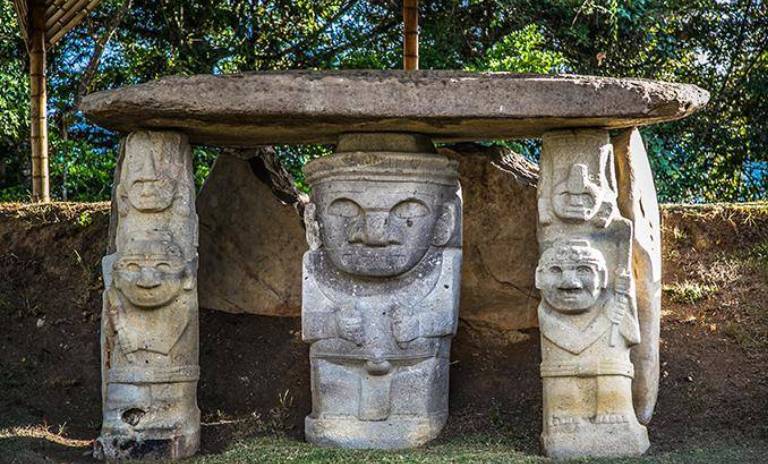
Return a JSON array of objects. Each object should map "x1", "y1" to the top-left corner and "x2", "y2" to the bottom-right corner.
[{"x1": 611, "y1": 129, "x2": 661, "y2": 424}]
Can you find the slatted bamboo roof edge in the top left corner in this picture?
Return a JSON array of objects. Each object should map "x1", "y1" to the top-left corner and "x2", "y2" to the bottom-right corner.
[{"x1": 13, "y1": 0, "x2": 101, "y2": 48}]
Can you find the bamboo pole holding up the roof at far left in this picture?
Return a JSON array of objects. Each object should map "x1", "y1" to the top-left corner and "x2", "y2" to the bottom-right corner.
[{"x1": 29, "y1": 0, "x2": 51, "y2": 203}]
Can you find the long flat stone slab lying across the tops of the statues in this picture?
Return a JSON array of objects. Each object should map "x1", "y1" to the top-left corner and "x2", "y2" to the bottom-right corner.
[{"x1": 80, "y1": 71, "x2": 709, "y2": 146}]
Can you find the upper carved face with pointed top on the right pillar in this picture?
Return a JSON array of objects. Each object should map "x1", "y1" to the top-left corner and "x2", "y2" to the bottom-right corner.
[{"x1": 552, "y1": 164, "x2": 602, "y2": 221}]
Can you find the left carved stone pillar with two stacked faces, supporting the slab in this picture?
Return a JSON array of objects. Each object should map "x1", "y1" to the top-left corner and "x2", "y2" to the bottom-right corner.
[{"x1": 94, "y1": 131, "x2": 200, "y2": 460}]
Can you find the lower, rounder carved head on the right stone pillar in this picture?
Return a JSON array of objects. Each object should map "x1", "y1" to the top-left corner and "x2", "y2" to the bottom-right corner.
[{"x1": 536, "y1": 240, "x2": 608, "y2": 314}]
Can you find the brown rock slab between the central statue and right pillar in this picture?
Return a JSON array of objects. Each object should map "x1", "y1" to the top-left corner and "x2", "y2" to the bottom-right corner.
[{"x1": 440, "y1": 144, "x2": 539, "y2": 335}]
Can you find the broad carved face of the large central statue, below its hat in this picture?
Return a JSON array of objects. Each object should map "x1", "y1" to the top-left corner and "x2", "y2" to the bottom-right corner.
[{"x1": 314, "y1": 180, "x2": 456, "y2": 277}]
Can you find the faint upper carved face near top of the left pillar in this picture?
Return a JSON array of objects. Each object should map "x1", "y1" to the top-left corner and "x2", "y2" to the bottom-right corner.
[{"x1": 123, "y1": 147, "x2": 177, "y2": 212}]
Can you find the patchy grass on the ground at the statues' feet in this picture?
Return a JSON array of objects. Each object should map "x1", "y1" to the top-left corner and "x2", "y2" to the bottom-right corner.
[{"x1": 0, "y1": 429, "x2": 768, "y2": 464}]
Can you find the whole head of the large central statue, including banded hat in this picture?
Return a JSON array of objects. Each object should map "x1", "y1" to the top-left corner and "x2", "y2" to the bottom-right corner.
[{"x1": 308, "y1": 153, "x2": 460, "y2": 277}]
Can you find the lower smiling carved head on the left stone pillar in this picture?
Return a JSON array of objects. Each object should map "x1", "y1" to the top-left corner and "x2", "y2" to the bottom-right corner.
[{"x1": 112, "y1": 237, "x2": 194, "y2": 309}]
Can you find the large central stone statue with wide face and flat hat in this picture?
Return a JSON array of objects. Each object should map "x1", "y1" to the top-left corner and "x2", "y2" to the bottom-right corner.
[{"x1": 302, "y1": 134, "x2": 461, "y2": 448}]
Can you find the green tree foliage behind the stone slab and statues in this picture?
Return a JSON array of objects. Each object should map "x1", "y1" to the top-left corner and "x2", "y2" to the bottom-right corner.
[{"x1": 0, "y1": 0, "x2": 768, "y2": 202}]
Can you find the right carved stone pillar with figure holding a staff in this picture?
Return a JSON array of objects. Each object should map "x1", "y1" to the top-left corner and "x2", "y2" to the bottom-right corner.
[{"x1": 536, "y1": 130, "x2": 649, "y2": 458}]
